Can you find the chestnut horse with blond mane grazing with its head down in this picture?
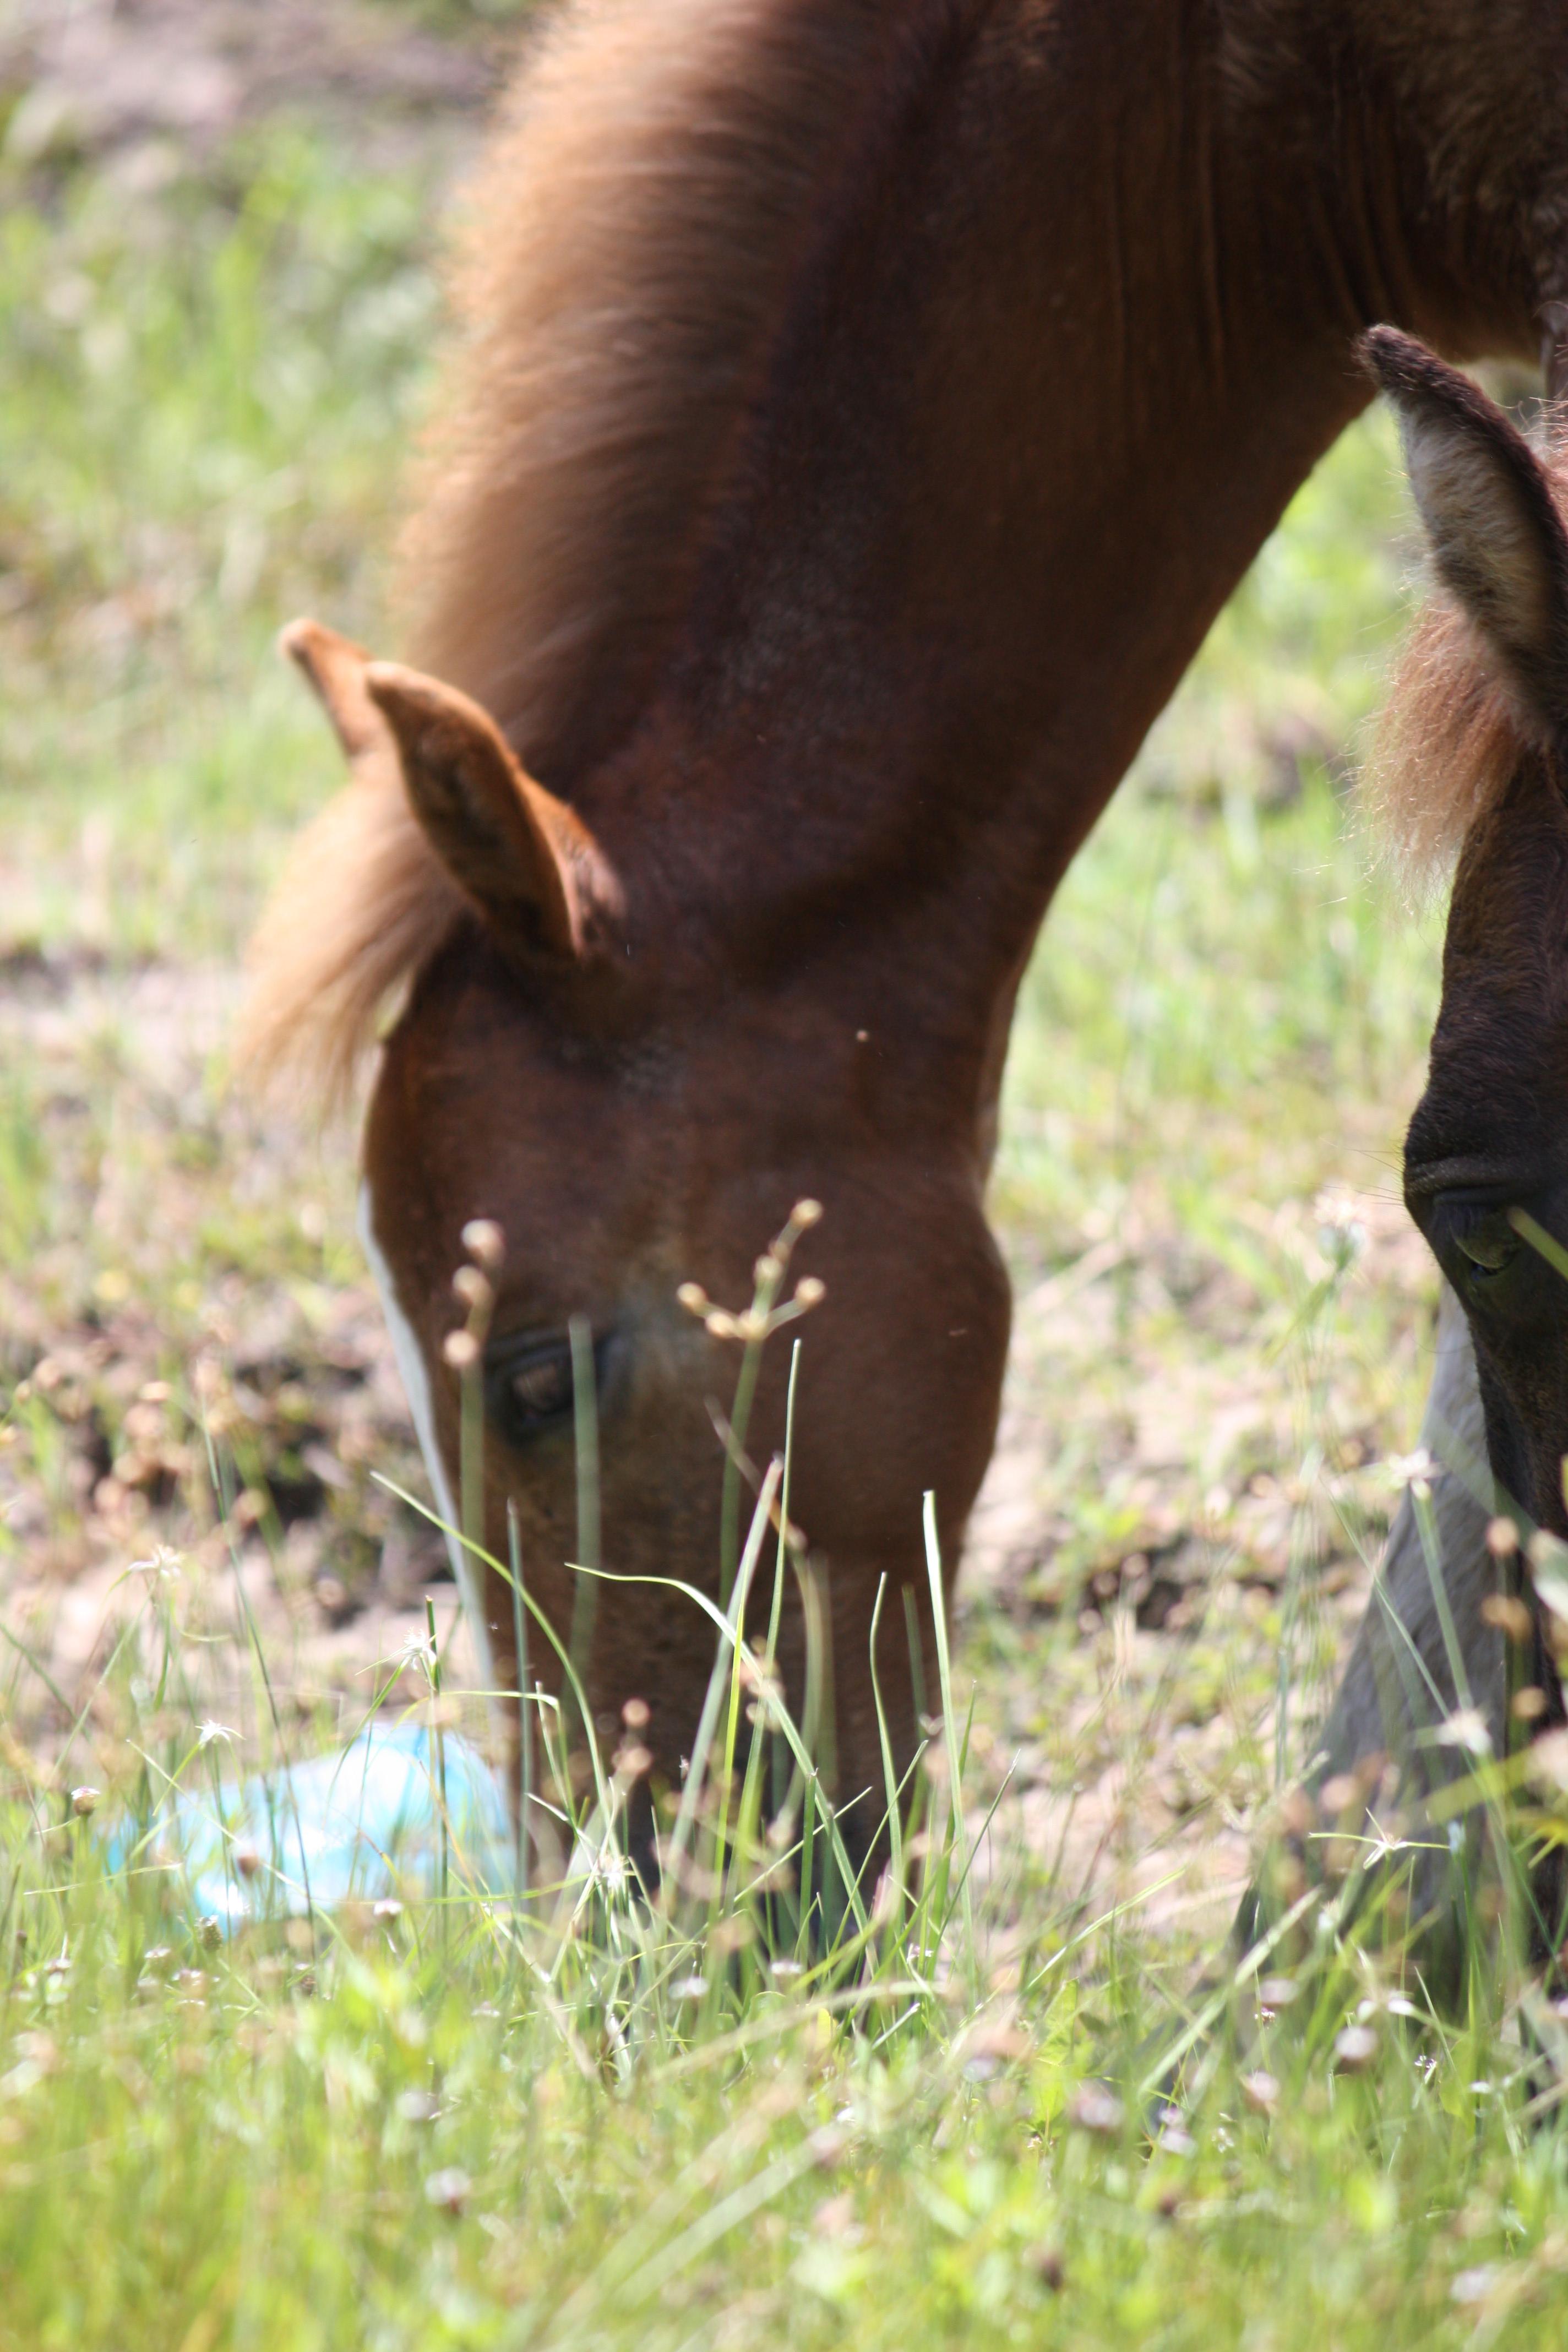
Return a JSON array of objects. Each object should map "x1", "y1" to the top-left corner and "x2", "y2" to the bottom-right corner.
[{"x1": 252, "y1": 0, "x2": 1568, "y2": 1872}]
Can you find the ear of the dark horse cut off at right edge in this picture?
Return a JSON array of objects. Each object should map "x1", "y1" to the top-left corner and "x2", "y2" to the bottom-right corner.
[{"x1": 1361, "y1": 327, "x2": 1568, "y2": 736}]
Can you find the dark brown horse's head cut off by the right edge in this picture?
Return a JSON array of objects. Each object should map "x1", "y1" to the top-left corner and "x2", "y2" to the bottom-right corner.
[{"x1": 1366, "y1": 329, "x2": 1568, "y2": 1950}]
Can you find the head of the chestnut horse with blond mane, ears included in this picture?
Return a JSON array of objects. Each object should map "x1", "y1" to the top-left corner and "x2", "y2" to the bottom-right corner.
[{"x1": 280, "y1": 623, "x2": 1009, "y2": 1853}]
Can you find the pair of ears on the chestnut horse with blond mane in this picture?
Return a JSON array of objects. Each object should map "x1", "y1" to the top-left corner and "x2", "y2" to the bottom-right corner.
[{"x1": 282, "y1": 621, "x2": 620, "y2": 957}]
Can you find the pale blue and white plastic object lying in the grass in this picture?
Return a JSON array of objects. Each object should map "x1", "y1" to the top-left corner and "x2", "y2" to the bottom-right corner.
[{"x1": 108, "y1": 1722, "x2": 517, "y2": 1934}]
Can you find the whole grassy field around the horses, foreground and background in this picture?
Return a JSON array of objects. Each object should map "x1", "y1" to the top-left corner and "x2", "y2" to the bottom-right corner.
[{"x1": 0, "y1": 73, "x2": 1568, "y2": 2352}]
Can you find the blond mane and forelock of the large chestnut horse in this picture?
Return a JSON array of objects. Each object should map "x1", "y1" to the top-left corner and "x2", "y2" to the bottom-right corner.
[{"x1": 242, "y1": 0, "x2": 922, "y2": 1093}]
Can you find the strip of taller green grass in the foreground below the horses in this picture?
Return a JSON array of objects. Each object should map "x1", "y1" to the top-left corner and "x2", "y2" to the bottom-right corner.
[{"x1": 0, "y1": 1430, "x2": 1568, "y2": 2352}]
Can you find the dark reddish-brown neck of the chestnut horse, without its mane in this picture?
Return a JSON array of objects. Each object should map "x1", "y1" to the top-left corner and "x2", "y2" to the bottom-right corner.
[{"x1": 581, "y1": 0, "x2": 1528, "y2": 1129}]
